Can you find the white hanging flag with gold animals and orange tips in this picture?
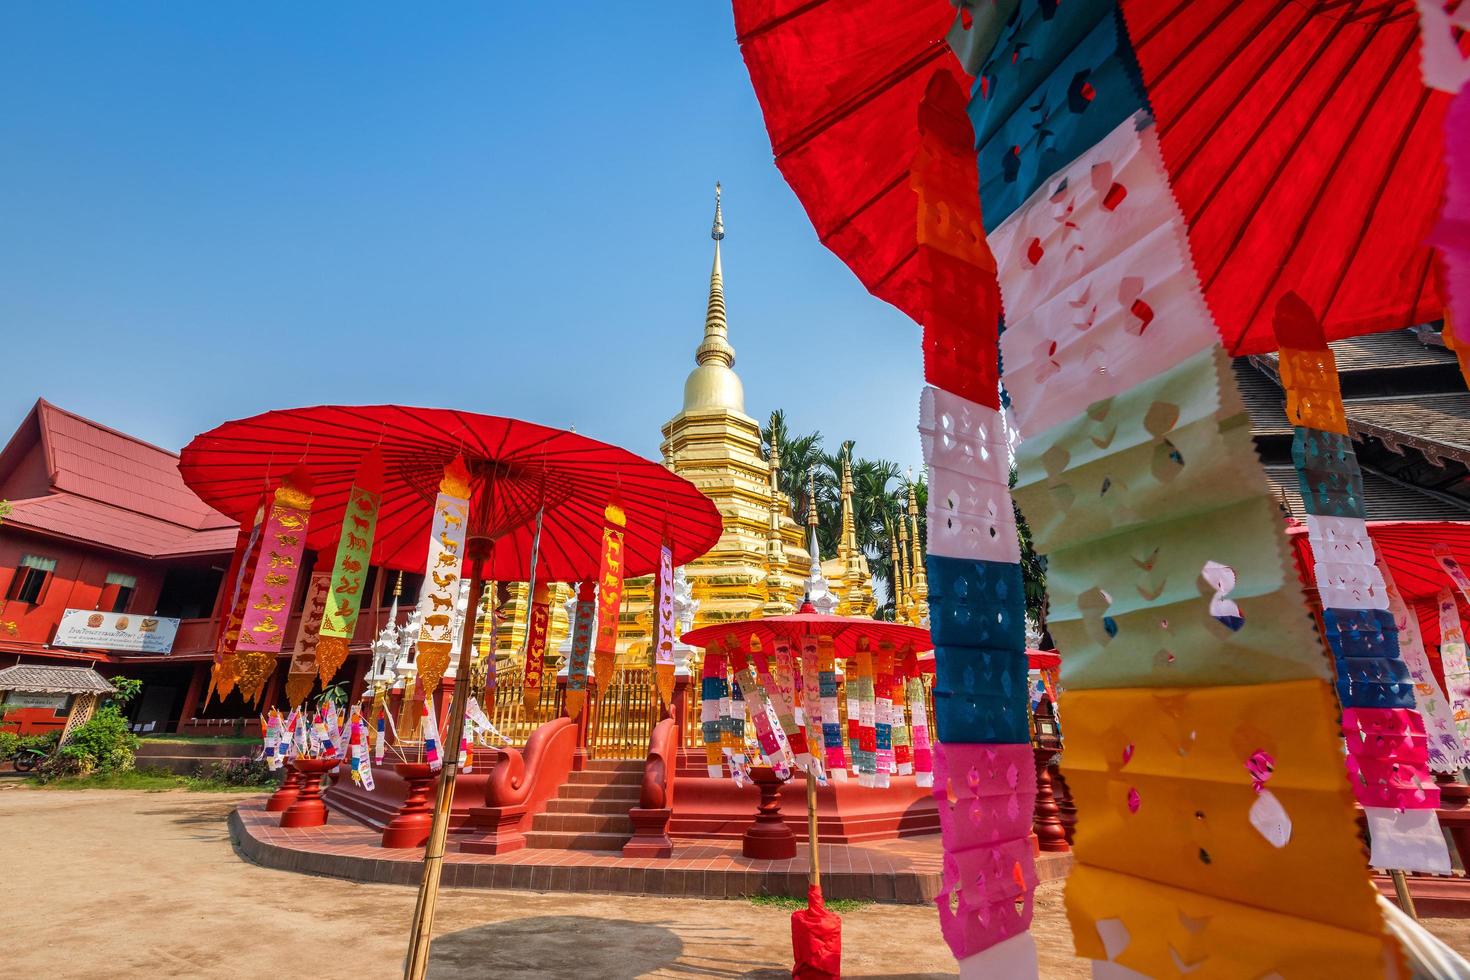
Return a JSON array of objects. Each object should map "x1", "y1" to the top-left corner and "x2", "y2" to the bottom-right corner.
[{"x1": 416, "y1": 457, "x2": 470, "y2": 696}]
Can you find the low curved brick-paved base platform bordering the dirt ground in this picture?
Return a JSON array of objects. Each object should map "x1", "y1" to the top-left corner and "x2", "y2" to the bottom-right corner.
[{"x1": 229, "y1": 801, "x2": 1072, "y2": 905}]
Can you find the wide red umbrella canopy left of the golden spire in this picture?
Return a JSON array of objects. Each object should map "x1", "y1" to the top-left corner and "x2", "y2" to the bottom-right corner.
[{"x1": 179, "y1": 406, "x2": 722, "y2": 582}]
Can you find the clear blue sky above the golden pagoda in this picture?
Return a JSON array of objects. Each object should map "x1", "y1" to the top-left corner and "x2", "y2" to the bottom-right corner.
[{"x1": 0, "y1": 0, "x2": 922, "y2": 464}]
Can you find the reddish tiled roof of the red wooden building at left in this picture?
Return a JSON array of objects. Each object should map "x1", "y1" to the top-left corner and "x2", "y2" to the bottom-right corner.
[{"x1": 7, "y1": 400, "x2": 237, "y2": 558}]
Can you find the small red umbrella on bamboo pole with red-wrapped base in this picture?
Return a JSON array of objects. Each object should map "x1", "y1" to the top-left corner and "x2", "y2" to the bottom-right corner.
[{"x1": 679, "y1": 602, "x2": 933, "y2": 980}]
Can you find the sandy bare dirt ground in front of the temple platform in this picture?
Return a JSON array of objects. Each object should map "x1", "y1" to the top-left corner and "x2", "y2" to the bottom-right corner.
[{"x1": 0, "y1": 780, "x2": 1470, "y2": 980}]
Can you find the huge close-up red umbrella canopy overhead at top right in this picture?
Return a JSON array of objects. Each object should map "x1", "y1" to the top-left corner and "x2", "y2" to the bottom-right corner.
[{"x1": 734, "y1": 0, "x2": 1470, "y2": 354}]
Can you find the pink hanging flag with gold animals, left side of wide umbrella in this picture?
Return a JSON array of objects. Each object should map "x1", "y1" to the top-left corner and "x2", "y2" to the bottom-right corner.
[{"x1": 235, "y1": 467, "x2": 312, "y2": 701}]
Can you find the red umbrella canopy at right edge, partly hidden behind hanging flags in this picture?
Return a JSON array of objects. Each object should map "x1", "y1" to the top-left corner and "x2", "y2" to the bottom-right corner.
[{"x1": 1286, "y1": 520, "x2": 1470, "y2": 657}]
